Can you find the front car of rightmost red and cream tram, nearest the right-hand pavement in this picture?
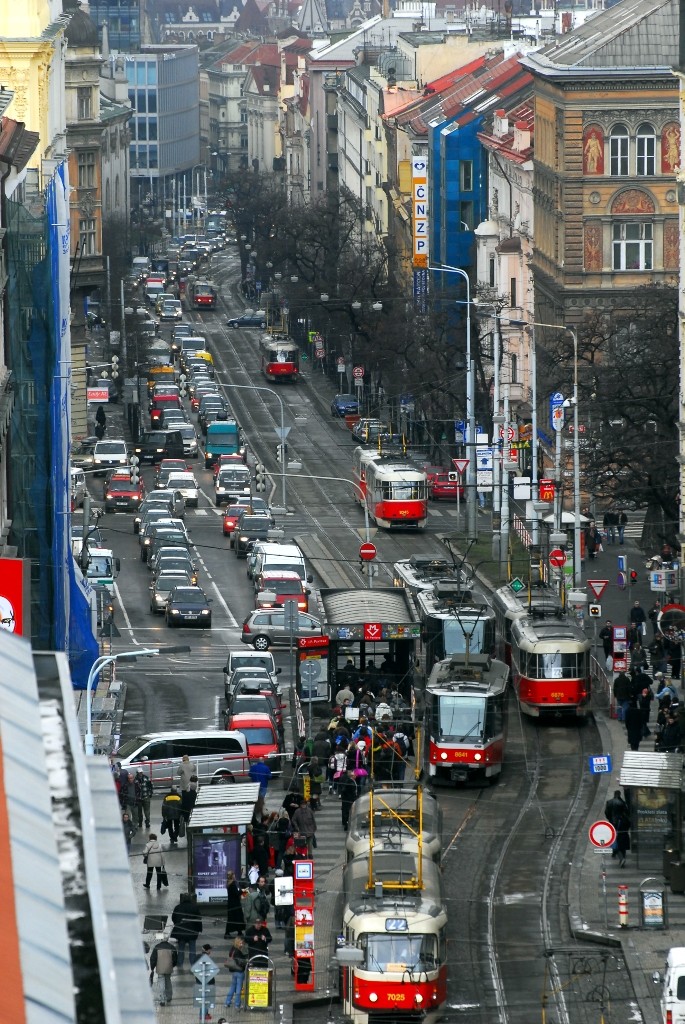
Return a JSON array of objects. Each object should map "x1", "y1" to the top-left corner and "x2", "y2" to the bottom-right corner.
[{"x1": 511, "y1": 618, "x2": 591, "y2": 718}]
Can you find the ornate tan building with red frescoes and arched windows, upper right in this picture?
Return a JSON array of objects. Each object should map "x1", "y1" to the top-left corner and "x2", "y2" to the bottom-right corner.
[{"x1": 522, "y1": 0, "x2": 680, "y2": 323}]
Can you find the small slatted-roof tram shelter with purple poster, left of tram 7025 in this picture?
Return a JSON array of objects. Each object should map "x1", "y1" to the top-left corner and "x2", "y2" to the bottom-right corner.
[{"x1": 186, "y1": 782, "x2": 259, "y2": 903}]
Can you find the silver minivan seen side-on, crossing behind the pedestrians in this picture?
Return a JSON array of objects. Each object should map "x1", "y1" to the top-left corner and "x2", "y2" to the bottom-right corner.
[{"x1": 111, "y1": 730, "x2": 250, "y2": 788}]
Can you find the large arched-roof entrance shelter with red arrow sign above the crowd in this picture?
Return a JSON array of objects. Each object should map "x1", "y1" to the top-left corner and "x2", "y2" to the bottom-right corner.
[{"x1": 320, "y1": 587, "x2": 421, "y2": 699}]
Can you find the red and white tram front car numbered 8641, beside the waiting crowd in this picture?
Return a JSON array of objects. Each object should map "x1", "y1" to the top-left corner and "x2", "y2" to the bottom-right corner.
[{"x1": 424, "y1": 654, "x2": 509, "y2": 783}]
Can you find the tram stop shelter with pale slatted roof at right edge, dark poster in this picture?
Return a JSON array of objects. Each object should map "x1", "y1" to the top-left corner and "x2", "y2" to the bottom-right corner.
[{"x1": 618, "y1": 751, "x2": 683, "y2": 869}]
